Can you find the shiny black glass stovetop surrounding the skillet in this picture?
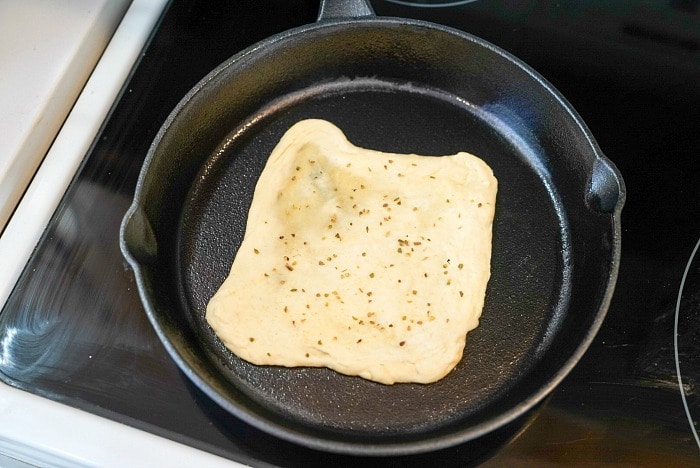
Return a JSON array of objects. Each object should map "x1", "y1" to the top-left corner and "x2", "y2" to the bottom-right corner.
[{"x1": 0, "y1": 0, "x2": 700, "y2": 466}]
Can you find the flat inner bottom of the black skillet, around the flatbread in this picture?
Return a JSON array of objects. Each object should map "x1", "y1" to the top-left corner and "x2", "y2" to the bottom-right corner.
[{"x1": 175, "y1": 79, "x2": 571, "y2": 441}]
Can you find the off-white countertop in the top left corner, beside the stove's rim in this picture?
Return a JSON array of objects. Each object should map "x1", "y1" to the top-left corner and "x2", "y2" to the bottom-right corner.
[{"x1": 0, "y1": 0, "x2": 131, "y2": 230}]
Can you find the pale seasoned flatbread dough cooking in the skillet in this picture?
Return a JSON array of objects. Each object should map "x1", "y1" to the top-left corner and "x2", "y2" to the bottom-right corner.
[{"x1": 206, "y1": 120, "x2": 497, "y2": 384}]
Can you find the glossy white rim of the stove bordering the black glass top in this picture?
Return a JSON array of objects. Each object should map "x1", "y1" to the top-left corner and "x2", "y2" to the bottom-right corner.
[{"x1": 0, "y1": 0, "x2": 242, "y2": 467}]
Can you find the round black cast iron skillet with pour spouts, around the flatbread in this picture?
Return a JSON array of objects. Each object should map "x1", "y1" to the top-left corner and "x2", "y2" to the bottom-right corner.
[{"x1": 121, "y1": 0, "x2": 625, "y2": 455}]
